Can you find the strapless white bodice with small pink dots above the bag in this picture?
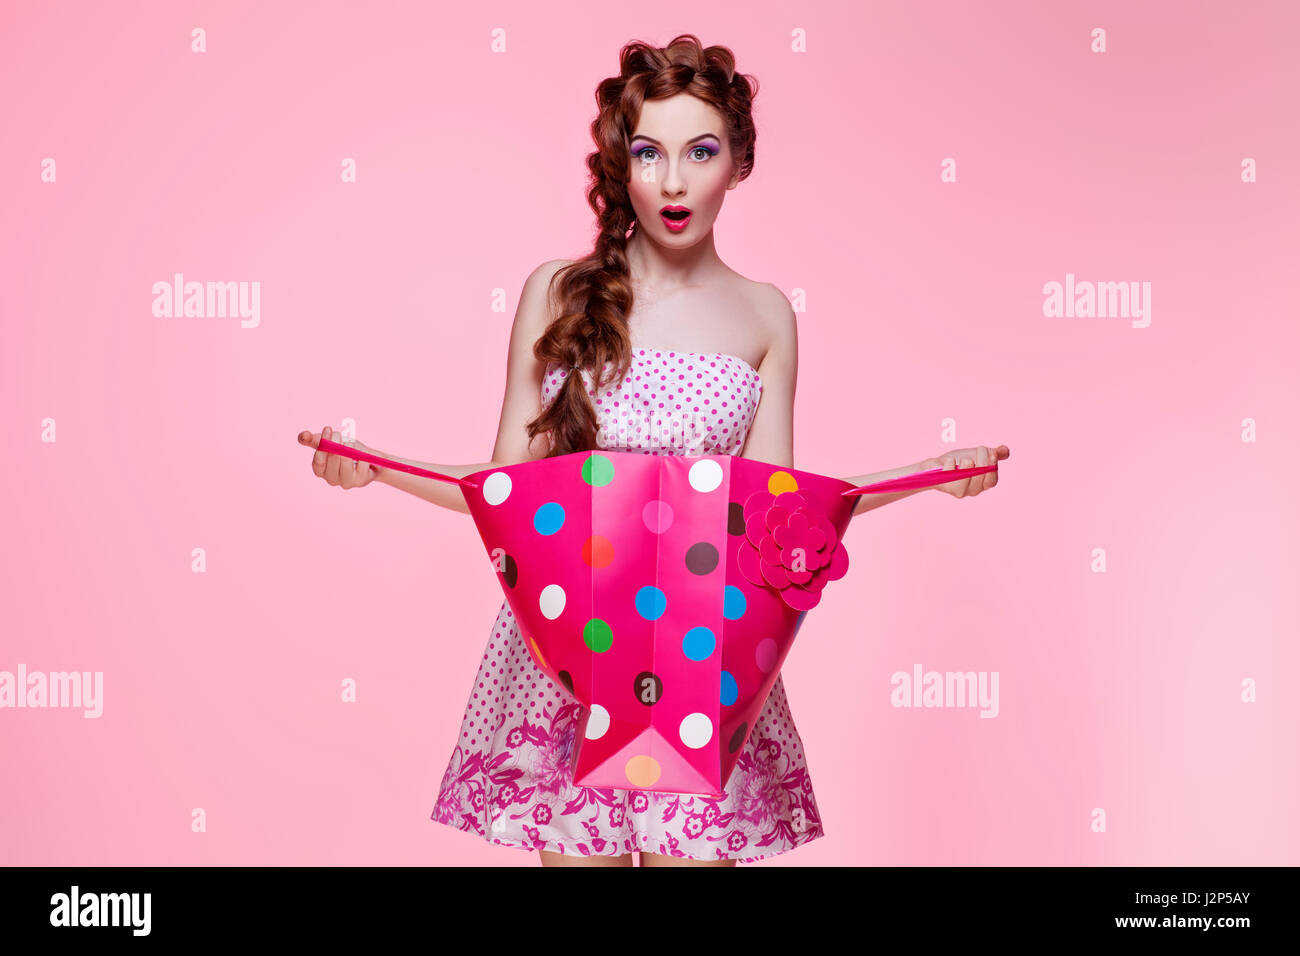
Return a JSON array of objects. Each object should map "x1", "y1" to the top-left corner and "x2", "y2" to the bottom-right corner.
[{"x1": 542, "y1": 349, "x2": 763, "y2": 455}]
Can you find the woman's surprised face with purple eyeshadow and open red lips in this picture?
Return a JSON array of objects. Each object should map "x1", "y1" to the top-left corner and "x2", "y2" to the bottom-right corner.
[{"x1": 628, "y1": 92, "x2": 740, "y2": 248}]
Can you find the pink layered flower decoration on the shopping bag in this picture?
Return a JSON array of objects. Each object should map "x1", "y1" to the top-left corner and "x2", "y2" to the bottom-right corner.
[{"x1": 736, "y1": 492, "x2": 849, "y2": 611}]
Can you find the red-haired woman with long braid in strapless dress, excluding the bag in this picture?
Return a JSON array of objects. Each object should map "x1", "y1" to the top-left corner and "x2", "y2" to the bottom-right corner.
[{"x1": 299, "y1": 35, "x2": 1009, "y2": 866}]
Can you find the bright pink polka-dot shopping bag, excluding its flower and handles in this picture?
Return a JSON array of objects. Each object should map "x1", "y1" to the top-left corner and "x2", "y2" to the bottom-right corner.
[{"x1": 467, "y1": 439, "x2": 853, "y2": 796}]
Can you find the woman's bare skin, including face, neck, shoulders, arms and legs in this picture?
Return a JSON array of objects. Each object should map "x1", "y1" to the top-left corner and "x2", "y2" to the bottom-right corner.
[{"x1": 298, "y1": 94, "x2": 1010, "y2": 866}]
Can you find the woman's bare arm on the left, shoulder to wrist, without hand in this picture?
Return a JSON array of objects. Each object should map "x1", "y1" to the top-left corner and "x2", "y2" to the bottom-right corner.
[{"x1": 374, "y1": 259, "x2": 568, "y2": 514}]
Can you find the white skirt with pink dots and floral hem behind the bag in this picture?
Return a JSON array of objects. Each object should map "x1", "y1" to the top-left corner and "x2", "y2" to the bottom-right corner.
[{"x1": 430, "y1": 601, "x2": 823, "y2": 862}]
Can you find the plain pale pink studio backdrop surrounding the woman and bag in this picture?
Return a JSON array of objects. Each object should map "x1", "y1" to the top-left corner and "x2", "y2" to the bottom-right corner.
[{"x1": 0, "y1": 1, "x2": 1300, "y2": 866}]
